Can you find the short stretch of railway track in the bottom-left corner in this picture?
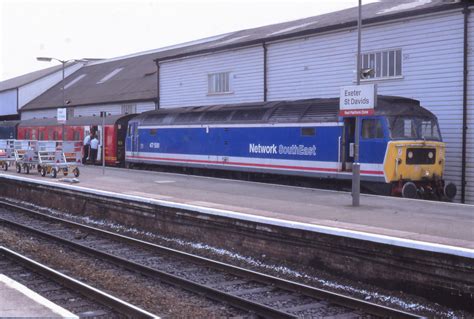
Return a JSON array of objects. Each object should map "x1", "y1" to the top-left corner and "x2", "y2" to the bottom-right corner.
[{"x1": 0, "y1": 246, "x2": 155, "y2": 318}]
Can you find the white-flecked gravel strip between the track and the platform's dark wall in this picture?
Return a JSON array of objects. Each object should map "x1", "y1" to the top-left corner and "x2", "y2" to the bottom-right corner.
[{"x1": 5, "y1": 202, "x2": 474, "y2": 318}]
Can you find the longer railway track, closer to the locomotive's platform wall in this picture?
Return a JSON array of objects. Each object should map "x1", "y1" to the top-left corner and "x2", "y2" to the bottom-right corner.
[{"x1": 0, "y1": 202, "x2": 419, "y2": 318}]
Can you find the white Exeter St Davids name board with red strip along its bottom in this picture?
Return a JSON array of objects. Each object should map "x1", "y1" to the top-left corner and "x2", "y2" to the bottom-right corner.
[{"x1": 339, "y1": 84, "x2": 377, "y2": 116}]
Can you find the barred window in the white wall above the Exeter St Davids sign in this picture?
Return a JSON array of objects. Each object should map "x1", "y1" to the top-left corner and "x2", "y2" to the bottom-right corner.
[{"x1": 360, "y1": 49, "x2": 402, "y2": 79}]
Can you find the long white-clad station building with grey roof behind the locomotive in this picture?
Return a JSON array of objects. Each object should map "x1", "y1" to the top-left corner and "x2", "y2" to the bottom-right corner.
[{"x1": 2, "y1": 0, "x2": 474, "y2": 204}]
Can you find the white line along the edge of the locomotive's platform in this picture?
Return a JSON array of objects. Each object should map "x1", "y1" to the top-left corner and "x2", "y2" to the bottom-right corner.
[{"x1": 0, "y1": 174, "x2": 474, "y2": 259}]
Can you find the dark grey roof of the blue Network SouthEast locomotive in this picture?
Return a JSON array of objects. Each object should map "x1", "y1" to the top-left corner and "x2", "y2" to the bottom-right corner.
[{"x1": 132, "y1": 96, "x2": 434, "y2": 125}]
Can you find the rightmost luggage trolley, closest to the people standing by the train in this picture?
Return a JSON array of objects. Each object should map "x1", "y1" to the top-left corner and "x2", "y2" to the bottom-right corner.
[{"x1": 38, "y1": 141, "x2": 81, "y2": 178}]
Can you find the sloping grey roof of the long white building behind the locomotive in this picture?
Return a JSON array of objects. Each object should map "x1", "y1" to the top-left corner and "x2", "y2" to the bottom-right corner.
[{"x1": 22, "y1": 0, "x2": 467, "y2": 111}]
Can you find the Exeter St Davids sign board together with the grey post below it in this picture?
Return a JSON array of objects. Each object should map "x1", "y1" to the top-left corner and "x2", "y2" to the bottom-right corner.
[{"x1": 339, "y1": 84, "x2": 377, "y2": 206}]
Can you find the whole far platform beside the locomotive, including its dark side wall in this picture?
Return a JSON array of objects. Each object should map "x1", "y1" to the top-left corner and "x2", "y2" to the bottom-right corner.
[{"x1": 0, "y1": 166, "x2": 474, "y2": 309}]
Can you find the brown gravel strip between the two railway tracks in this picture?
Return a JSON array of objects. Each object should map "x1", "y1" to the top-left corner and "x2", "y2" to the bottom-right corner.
[{"x1": 0, "y1": 226, "x2": 245, "y2": 318}]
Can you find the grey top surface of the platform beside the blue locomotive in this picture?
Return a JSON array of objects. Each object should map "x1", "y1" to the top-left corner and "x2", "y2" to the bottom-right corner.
[{"x1": 0, "y1": 166, "x2": 474, "y2": 250}]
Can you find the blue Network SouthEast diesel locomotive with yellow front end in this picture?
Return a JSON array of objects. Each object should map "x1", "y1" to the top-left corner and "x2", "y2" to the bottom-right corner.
[{"x1": 125, "y1": 96, "x2": 456, "y2": 199}]
